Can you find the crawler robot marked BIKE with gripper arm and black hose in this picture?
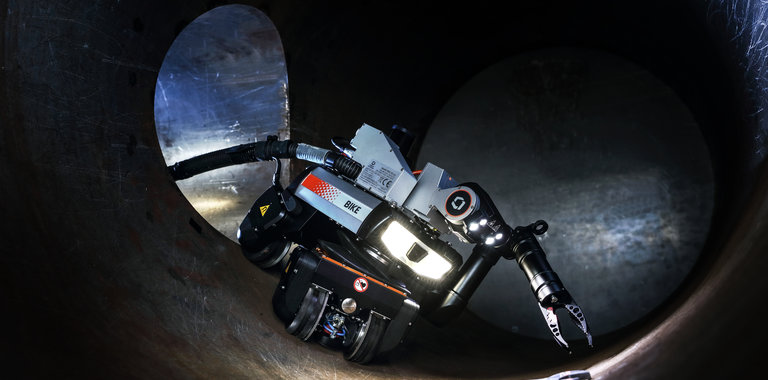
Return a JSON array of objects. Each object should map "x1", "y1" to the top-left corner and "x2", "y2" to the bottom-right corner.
[{"x1": 168, "y1": 124, "x2": 592, "y2": 363}]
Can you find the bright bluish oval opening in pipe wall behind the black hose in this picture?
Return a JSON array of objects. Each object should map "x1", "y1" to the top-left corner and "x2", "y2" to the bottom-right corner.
[{"x1": 155, "y1": 5, "x2": 288, "y2": 240}]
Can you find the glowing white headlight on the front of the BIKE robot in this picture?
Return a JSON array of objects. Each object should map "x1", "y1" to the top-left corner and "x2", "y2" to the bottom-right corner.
[{"x1": 381, "y1": 221, "x2": 451, "y2": 279}]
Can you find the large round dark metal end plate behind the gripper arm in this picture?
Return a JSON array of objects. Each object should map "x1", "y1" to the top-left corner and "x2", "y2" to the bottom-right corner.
[{"x1": 417, "y1": 49, "x2": 714, "y2": 339}]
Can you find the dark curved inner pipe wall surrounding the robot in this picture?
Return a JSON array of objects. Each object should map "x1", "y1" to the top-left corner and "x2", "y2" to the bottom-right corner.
[{"x1": 0, "y1": 0, "x2": 768, "y2": 379}]
